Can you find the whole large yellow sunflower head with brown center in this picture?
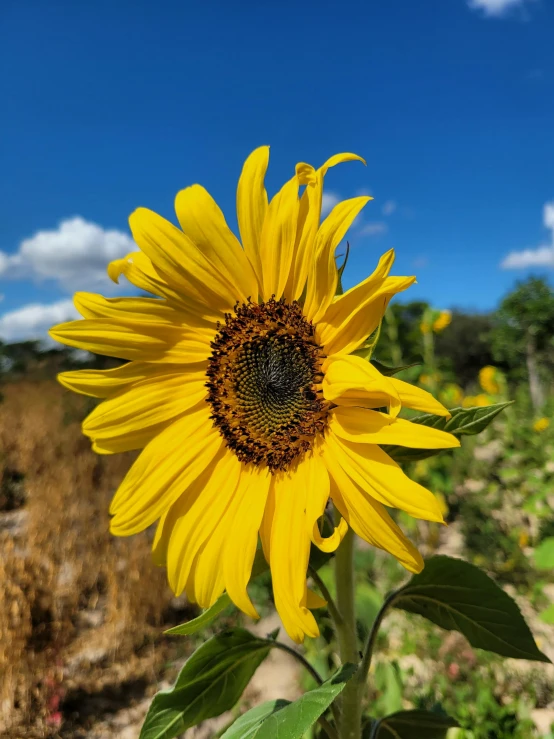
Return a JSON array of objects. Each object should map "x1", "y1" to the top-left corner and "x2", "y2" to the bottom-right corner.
[{"x1": 50, "y1": 147, "x2": 459, "y2": 642}]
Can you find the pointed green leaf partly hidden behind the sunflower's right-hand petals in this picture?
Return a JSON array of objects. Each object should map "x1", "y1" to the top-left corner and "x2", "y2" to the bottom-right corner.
[{"x1": 382, "y1": 401, "x2": 513, "y2": 462}]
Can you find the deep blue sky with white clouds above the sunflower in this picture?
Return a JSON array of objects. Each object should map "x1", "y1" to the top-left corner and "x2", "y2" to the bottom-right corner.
[{"x1": 0, "y1": 0, "x2": 554, "y2": 340}]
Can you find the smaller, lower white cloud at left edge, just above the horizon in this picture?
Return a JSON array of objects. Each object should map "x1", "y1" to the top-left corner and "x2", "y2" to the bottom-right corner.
[{"x1": 0, "y1": 300, "x2": 79, "y2": 344}]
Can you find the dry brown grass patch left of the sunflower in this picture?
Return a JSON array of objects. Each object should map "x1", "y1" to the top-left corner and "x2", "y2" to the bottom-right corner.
[{"x1": 0, "y1": 381, "x2": 188, "y2": 737}]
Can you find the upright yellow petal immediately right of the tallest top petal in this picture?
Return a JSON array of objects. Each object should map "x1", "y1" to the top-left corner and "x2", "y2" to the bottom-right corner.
[{"x1": 260, "y1": 175, "x2": 299, "y2": 300}]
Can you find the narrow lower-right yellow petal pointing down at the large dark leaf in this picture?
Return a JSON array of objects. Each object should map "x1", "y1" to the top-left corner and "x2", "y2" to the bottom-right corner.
[{"x1": 329, "y1": 464, "x2": 423, "y2": 572}]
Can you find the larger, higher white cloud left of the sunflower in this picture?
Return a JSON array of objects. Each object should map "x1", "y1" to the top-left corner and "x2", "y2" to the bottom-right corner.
[{"x1": 0, "y1": 216, "x2": 137, "y2": 292}]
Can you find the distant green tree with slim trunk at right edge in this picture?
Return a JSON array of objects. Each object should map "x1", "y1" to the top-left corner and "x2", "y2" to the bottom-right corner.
[{"x1": 491, "y1": 277, "x2": 554, "y2": 411}]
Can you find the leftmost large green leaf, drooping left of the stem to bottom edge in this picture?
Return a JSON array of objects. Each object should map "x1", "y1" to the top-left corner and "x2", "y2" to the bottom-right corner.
[{"x1": 140, "y1": 629, "x2": 272, "y2": 739}]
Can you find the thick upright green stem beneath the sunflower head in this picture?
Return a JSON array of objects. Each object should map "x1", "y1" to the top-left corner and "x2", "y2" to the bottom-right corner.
[{"x1": 335, "y1": 529, "x2": 362, "y2": 739}]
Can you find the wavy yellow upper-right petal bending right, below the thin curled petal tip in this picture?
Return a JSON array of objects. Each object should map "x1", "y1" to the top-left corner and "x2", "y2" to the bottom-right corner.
[{"x1": 304, "y1": 197, "x2": 371, "y2": 322}]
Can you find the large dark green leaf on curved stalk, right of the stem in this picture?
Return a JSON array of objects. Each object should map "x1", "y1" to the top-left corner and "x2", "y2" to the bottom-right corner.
[{"x1": 393, "y1": 556, "x2": 550, "y2": 662}]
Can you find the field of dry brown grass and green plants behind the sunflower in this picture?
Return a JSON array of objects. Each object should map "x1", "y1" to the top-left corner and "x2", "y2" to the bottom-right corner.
[{"x1": 0, "y1": 282, "x2": 554, "y2": 739}]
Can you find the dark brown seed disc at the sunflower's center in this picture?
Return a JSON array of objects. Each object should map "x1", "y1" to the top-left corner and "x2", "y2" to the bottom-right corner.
[{"x1": 207, "y1": 299, "x2": 328, "y2": 472}]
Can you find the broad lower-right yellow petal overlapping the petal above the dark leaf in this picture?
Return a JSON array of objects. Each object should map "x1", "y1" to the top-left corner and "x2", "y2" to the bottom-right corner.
[{"x1": 324, "y1": 433, "x2": 443, "y2": 522}]
